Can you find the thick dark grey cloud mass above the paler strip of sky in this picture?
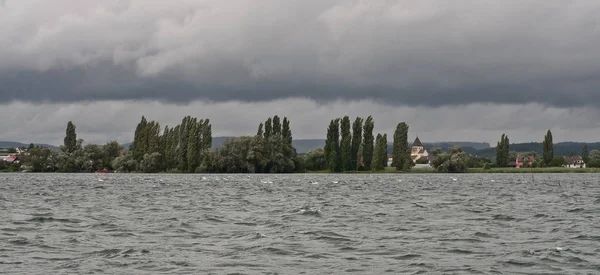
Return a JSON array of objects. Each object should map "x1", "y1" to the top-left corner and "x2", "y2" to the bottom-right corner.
[{"x1": 0, "y1": 0, "x2": 600, "y2": 107}]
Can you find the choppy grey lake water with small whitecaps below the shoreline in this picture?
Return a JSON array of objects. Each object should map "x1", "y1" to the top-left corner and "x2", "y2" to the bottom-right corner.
[{"x1": 0, "y1": 174, "x2": 600, "y2": 274}]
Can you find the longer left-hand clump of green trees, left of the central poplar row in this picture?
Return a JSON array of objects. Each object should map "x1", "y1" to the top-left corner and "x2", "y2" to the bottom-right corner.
[{"x1": 11, "y1": 116, "x2": 304, "y2": 173}]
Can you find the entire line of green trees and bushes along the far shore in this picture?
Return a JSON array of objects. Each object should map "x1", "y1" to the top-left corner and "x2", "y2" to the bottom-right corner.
[{"x1": 8, "y1": 119, "x2": 600, "y2": 173}]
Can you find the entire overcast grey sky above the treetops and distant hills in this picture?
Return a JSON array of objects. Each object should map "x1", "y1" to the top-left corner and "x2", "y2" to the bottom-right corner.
[{"x1": 0, "y1": 0, "x2": 600, "y2": 147}]
